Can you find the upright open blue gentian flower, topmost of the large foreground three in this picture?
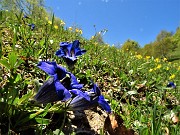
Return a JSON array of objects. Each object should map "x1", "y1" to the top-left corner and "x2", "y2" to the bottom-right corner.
[{"x1": 56, "y1": 40, "x2": 86, "y2": 66}]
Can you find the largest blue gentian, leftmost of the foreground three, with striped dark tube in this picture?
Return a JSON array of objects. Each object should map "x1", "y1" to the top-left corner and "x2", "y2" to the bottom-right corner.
[{"x1": 34, "y1": 62, "x2": 90, "y2": 103}]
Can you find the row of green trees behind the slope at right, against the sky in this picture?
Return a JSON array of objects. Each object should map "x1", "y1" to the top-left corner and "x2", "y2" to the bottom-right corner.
[{"x1": 120, "y1": 27, "x2": 180, "y2": 58}]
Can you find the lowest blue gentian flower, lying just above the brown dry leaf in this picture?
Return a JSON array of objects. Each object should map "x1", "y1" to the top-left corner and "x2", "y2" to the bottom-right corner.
[{"x1": 69, "y1": 84, "x2": 111, "y2": 113}]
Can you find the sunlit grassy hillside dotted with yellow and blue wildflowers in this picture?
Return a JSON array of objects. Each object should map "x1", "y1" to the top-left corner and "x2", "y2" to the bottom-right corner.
[{"x1": 0, "y1": 1, "x2": 180, "y2": 135}]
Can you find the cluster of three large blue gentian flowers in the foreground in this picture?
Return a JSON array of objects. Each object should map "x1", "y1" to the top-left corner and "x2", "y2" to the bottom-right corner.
[{"x1": 34, "y1": 40, "x2": 111, "y2": 113}]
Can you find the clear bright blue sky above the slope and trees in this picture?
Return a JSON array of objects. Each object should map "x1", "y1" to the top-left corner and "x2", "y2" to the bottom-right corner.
[{"x1": 45, "y1": 0, "x2": 180, "y2": 46}]
